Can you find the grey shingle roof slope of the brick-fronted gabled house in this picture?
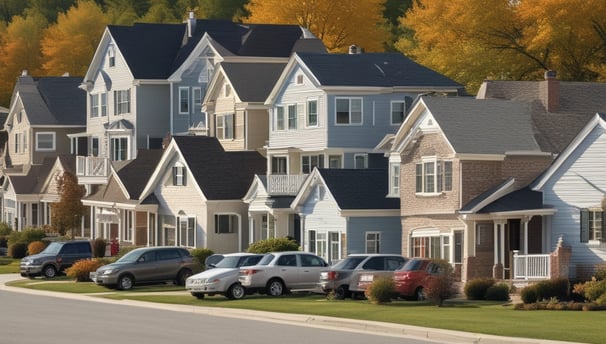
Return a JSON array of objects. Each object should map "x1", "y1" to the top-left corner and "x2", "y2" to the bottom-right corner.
[{"x1": 422, "y1": 96, "x2": 540, "y2": 154}]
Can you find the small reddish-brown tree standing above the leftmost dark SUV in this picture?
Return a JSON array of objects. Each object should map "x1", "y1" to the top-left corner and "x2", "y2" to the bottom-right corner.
[{"x1": 51, "y1": 171, "x2": 86, "y2": 239}]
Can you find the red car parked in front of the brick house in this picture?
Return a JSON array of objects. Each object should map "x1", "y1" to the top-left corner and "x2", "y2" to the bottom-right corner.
[{"x1": 393, "y1": 258, "x2": 440, "y2": 301}]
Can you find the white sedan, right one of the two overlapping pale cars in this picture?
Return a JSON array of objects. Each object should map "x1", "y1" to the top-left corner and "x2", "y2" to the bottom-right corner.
[{"x1": 239, "y1": 251, "x2": 328, "y2": 296}]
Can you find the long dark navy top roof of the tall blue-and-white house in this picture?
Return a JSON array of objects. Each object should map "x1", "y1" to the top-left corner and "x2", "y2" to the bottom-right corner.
[{"x1": 297, "y1": 53, "x2": 463, "y2": 88}]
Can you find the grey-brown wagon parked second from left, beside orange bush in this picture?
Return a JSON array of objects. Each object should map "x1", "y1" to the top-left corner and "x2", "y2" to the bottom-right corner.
[{"x1": 90, "y1": 246, "x2": 202, "y2": 290}]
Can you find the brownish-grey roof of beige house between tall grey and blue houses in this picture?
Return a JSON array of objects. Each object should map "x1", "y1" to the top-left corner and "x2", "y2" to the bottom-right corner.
[{"x1": 221, "y1": 62, "x2": 286, "y2": 102}]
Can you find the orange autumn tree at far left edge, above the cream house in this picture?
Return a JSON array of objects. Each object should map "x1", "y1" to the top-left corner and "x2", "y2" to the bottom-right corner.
[{"x1": 0, "y1": 11, "x2": 48, "y2": 107}]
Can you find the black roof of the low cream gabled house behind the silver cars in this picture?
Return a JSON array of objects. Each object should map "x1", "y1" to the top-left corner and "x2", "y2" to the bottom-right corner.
[{"x1": 173, "y1": 136, "x2": 267, "y2": 200}]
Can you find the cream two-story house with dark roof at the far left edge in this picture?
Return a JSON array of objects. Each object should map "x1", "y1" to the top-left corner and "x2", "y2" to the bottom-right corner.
[{"x1": 0, "y1": 71, "x2": 86, "y2": 230}]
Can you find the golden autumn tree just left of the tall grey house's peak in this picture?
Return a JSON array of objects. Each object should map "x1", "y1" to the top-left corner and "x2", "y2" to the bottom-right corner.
[{"x1": 42, "y1": 0, "x2": 107, "y2": 75}]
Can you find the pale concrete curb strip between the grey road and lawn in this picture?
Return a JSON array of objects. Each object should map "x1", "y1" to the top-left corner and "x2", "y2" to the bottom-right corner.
[{"x1": 0, "y1": 274, "x2": 580, "y2": 344}]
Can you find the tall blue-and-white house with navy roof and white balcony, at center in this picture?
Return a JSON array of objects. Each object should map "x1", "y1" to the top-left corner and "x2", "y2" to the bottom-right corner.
[{"x1": 245, "y1": 47, "x2": 463, "y2": 260}]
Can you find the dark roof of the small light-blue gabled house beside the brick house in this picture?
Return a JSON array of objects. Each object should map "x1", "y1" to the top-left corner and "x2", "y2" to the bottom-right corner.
[{"x1": 319, "y1": 169, "x2": 400, "y2": 210}]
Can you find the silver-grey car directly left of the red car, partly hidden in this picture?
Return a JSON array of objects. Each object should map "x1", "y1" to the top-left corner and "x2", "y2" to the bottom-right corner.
[{"x1": 349, "y1": 257, "x2": 407, "y2": 299}]
